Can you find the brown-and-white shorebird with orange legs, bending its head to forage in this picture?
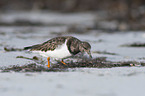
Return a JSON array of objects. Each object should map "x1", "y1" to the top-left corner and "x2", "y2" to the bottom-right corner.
[{"x1": 24, "y1": 36, "x2": 92, "y2": 68}]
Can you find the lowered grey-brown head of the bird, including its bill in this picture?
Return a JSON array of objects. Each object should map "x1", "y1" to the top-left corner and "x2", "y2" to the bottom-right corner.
[{"x1": 79, "y1": 42, "x2": 92, "y2": 58}]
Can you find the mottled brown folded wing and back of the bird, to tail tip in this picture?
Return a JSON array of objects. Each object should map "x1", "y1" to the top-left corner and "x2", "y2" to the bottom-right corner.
[{"x1": 24, "y1": 37, "x2": 66, "y2": 52}]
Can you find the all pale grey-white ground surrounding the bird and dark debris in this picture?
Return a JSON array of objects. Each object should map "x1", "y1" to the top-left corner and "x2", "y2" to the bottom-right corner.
[{"x1": 0, "y1": 13, "x2": 145, "y2": 96}]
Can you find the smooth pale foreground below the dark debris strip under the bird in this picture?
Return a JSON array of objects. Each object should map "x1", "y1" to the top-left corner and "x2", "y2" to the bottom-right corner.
[{"x1": 0, "y1": 67, "x2": 145, "y2": 96}]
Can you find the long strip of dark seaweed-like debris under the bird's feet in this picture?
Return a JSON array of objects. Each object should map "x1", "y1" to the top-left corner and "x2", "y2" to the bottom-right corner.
[{"x1": 0, "y1": 57, "x2": 145, "y2": 72}]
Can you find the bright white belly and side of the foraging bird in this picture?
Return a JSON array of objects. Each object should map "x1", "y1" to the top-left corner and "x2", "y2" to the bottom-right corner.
[{"x1": 33, "y1": 40, "x2": 71, "y2": 58}]
